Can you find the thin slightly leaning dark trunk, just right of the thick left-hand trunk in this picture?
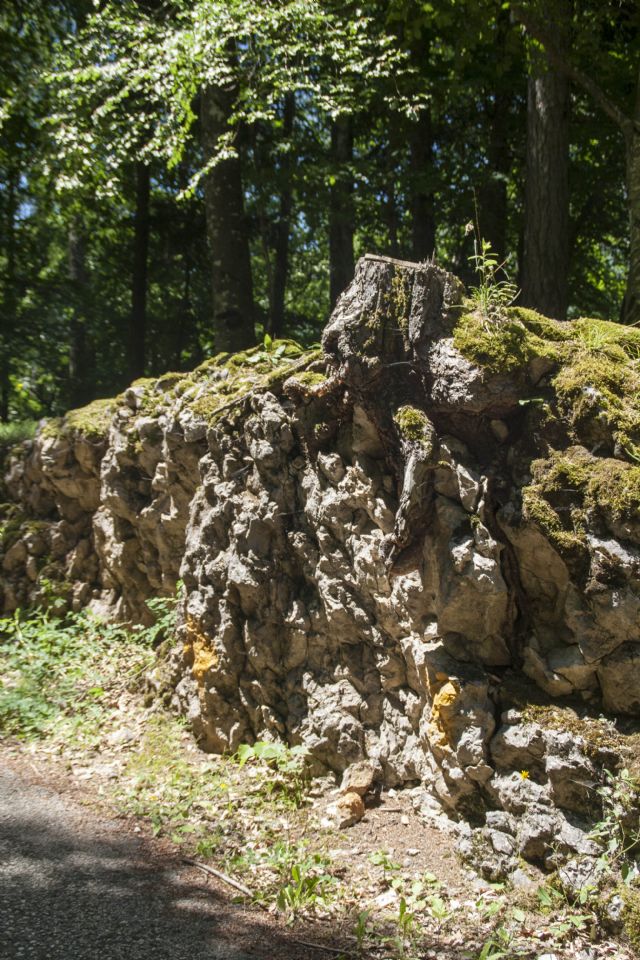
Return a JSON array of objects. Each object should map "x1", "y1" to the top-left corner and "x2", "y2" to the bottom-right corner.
[{"x1": 269, "y1": 93, "x2": 296, "y2": 337}]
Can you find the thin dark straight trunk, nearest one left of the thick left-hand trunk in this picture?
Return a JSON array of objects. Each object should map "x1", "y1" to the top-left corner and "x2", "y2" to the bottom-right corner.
[{"x1": 127, "y1": 161, "x2": 151, "y2": 380}]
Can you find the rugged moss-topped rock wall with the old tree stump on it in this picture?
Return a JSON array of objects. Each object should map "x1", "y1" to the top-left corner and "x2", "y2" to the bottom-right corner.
[{"x1": 2, "y1": 257, "x2": 640, "y2": 875}]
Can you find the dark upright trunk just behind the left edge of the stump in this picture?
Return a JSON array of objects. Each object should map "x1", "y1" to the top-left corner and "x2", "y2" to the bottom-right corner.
[{"x1": 329, "y1": 117, "x2": 355, "y2": 306}]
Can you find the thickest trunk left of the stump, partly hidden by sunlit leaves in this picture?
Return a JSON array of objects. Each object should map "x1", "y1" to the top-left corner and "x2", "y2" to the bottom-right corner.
[{"x1": 201, "y1": 86, "x2": 255, "y2": 351}]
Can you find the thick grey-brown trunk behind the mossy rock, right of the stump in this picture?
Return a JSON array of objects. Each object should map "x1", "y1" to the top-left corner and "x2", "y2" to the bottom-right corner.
[{"x1": 520, "y1": 2, "x2": 570, "y2": 320}]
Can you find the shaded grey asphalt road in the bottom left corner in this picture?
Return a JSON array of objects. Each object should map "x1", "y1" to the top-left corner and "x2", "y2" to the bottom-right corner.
[{"x1": 0, "y1": 761, "x2": 312, "y2": 960}]
